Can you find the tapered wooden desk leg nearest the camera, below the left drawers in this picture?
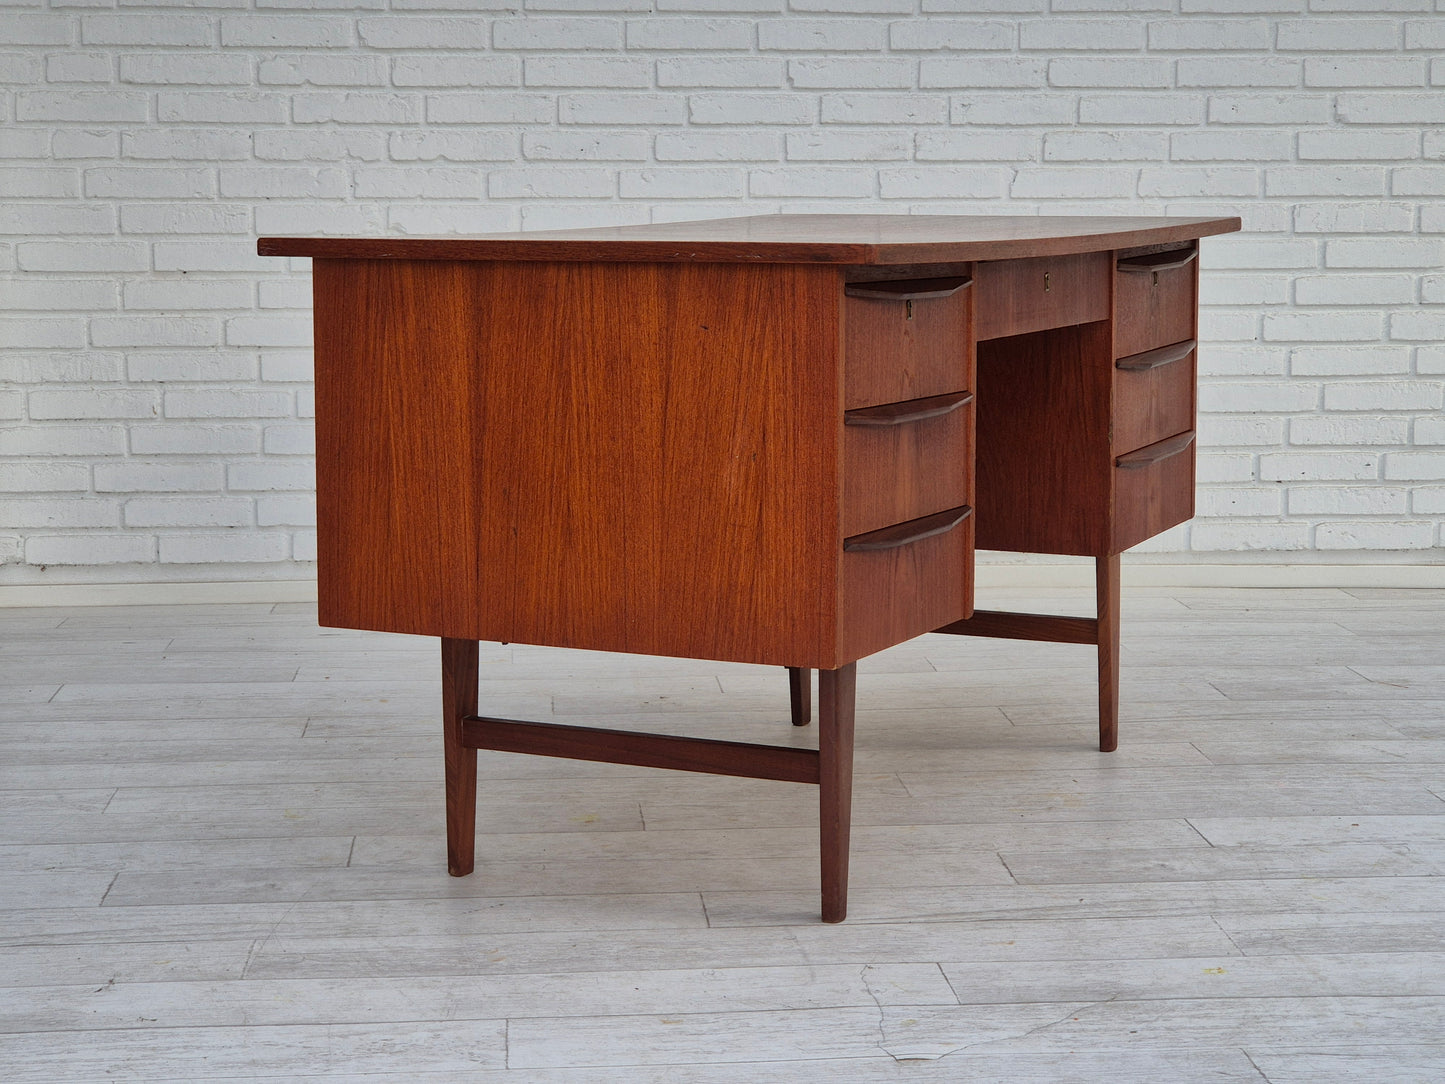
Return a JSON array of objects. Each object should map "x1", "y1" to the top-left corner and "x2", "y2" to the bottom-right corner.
[{"x1": 818, "y1": 662, "x2": 857, "y2": 922}]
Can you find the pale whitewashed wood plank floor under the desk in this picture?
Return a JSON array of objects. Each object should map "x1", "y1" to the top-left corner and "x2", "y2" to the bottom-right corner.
[{"x1": 0, "y1": 590, "x2": 1445, "y2": 1084}]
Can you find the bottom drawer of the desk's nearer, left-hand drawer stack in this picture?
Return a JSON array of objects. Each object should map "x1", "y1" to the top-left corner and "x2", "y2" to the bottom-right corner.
[{"x1": 838, "y1": 507, "x2": 974, "y2": 661}]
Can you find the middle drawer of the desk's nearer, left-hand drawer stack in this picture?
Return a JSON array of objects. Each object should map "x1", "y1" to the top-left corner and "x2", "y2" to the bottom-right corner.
[{"x1": 842, "y1": 392, "x2": 974, "y2": 535}]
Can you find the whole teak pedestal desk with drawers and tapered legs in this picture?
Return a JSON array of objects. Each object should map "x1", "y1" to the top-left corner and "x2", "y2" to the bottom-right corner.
[{"x1": 259, "y1": 215, "x2": 1240, "y2": 922}]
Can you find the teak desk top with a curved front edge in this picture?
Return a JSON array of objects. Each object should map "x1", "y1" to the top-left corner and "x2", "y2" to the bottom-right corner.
[{"x1": 257, "y1": 214, "x2": 1240, "y2": 264}]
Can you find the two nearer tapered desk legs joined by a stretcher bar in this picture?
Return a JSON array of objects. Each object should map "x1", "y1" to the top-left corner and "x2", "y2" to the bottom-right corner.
[{"x1": 442, "y1": 637, "x2": 857, "y2": 922}]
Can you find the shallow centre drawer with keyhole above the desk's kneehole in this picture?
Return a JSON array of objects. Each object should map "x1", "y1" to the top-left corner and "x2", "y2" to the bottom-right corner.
[{"x1": 974, "y1": 251, "x2": 1111, "y2": 340}]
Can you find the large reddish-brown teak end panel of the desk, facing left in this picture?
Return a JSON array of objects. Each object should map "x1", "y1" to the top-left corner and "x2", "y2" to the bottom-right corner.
[{"x1": 315, "y1": 260, "x2": 841, "y2": 666}]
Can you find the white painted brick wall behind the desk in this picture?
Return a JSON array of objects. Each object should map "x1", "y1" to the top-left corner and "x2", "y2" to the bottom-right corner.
[{"x1": 0, "y1": 0, "x2": 1445, "y2": 582}]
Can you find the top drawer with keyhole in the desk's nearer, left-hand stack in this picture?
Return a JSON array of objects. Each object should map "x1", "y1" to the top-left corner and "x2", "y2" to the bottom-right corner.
[{"x1": 842, "y1": 276, "x2": 971, "y2": 409}]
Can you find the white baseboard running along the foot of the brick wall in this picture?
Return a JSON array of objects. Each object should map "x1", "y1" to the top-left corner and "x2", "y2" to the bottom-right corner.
[{"x1": 0, "y1": 559, "x2": 1445, "y2": 608}]
